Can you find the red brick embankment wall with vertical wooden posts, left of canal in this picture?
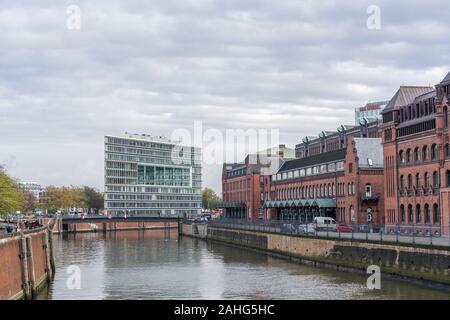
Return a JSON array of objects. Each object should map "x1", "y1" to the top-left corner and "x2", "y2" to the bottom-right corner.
[{"x1": 0, "y1": 227, "x2": 55, "y2": 300}]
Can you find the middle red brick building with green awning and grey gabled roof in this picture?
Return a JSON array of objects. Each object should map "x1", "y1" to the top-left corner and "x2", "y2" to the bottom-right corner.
[{"x1": 262, "y1": 138, "x2": 384, "y2": 224}]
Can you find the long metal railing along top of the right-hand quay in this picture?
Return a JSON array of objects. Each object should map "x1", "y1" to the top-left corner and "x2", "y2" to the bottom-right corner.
[{"x1": 208, "y1": 218, "x2": 450, "y2": 247}]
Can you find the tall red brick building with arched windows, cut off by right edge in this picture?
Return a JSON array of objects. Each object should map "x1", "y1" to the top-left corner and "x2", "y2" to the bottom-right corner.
[{"x1": 381, "y1": 73, "x2": 450, "y2": 234}]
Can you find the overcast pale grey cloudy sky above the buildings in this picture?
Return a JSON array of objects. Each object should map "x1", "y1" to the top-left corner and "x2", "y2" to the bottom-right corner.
[{"x1": 0, "y1": 0, "x2": 450, "y2": 191}]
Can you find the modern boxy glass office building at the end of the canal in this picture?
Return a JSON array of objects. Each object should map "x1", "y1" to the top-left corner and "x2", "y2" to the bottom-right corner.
[{"x1": 105, "y1": 134, "x2": 202, "y2": 217}]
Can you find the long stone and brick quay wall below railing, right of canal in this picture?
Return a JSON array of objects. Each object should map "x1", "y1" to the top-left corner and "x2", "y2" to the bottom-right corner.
[{"x1": 207, "y1": 226, "x2": 450, "y2": 290}]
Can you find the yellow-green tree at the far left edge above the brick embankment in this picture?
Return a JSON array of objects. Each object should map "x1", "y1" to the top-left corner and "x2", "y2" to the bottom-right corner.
[{"x1": 0, "y1": 167, "x2": 26, "y2": 216}]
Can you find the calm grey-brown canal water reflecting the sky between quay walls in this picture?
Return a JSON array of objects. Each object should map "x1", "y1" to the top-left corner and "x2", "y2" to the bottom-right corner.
[{"x1": 38, "y1": 230, "x2": 450, "y2": 299}]
